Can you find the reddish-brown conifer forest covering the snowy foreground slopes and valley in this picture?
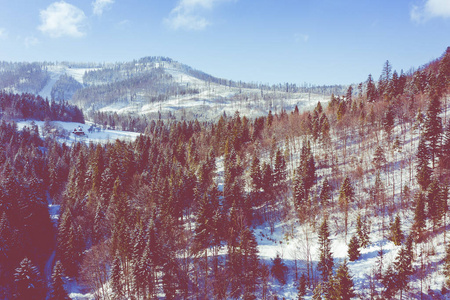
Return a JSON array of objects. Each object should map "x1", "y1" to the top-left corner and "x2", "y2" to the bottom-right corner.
[{"x1": 0, "y1": 48, "x2": 450, "y2": 299}]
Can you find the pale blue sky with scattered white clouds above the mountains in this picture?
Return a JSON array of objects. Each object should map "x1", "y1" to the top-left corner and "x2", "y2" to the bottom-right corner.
[{"x1": 0, "y1": 0, "x2": 450, "y2": 85}]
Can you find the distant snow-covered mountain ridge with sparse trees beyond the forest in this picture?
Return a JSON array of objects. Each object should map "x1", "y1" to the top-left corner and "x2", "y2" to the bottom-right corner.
[{"x1": 0, "y1": 57, "x2": 345, "y2": 120}]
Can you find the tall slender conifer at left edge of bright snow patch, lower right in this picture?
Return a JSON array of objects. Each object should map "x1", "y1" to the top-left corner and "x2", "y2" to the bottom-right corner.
[{"x1": 317, "y1": 217, "x2": 334, "y2": 282}]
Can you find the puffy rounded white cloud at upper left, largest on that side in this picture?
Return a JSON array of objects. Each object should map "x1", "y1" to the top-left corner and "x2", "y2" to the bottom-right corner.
[{"x1": 38, "y1": 1, "x2": 86, "y2": 38}]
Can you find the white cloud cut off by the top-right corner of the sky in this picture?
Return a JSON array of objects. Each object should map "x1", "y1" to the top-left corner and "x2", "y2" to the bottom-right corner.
[{"x1": 409, "y1": 0, "x2": 450, "y2": 23}]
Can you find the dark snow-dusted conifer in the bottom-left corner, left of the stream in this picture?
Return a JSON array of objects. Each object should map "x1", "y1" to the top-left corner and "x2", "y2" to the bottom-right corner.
[{"x1": 14, "y1": 258, "x2": 46, "y2": 300}]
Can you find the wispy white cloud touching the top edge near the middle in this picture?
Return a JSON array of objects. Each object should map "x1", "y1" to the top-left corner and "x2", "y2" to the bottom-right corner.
[{"x1": 164, "y1": 0, "x2": 233, "y2": 30}]
